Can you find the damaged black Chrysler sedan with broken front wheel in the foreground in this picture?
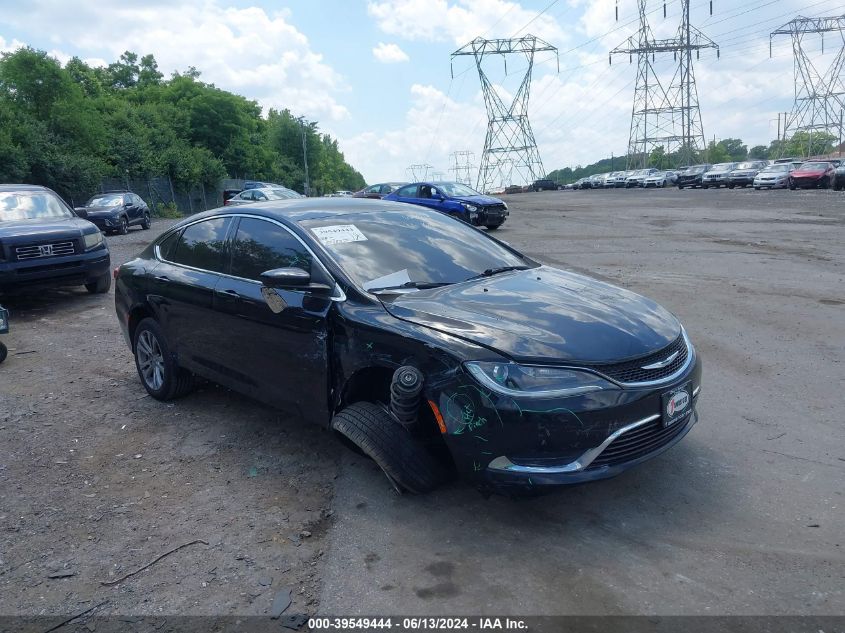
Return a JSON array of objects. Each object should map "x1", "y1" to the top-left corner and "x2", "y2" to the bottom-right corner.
[{"x1": 115, "y1": 198, "x2": 701, "y2": 493}]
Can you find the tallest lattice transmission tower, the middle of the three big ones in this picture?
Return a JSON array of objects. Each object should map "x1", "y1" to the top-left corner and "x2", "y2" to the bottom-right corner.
[{"x1": 610, "y1": 0, "x2": 719, "y2": 169}]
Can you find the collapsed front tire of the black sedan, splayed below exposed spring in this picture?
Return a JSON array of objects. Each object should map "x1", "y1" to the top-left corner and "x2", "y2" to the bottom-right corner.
[{"x1": 332, "y1": 402, "x2": 446, "y2": 494}]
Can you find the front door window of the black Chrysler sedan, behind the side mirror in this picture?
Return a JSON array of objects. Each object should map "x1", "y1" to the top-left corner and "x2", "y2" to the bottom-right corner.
[{"x1": 231, "y1": 218, "x2": 311, "y2": 279}]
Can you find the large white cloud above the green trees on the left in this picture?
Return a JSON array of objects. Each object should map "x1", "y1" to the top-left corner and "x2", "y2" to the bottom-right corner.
[{"x1": 0, "y1": 0, "x2": 349, "y2": 120}]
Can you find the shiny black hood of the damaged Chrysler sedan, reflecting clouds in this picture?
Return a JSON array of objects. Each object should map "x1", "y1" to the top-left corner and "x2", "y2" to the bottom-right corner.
[{"x1": 384, "y1": 266, "x2": 681, "y2": 363}]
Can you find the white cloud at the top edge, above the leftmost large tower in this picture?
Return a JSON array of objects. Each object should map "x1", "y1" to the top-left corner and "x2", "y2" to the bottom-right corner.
[{"x1": 367, "y1": 0, "x2": 567, "y2": 46}]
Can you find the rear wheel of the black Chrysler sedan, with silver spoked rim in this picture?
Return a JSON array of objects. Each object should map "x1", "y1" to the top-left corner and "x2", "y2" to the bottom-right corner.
[{"x1": 132, "y1": 317, "x2": 196, "y2": 401}]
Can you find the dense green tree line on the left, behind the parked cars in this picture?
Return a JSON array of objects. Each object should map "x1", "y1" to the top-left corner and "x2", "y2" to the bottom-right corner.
[{"x1": 0, "y1": 48, "x2": 365, "y2": 201}]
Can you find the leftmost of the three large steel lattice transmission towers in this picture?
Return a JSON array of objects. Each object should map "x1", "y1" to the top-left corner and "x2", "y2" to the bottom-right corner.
[{"x1": 451, "y1": 35, "x2": 560, "y2": 193}]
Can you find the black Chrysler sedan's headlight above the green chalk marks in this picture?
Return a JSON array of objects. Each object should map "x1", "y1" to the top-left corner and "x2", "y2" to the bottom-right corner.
[{"x1": 464, "y1": 361, "x2": 616, "y2": 398}]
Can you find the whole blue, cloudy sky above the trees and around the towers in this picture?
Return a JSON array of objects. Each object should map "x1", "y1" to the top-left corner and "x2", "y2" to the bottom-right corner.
[{"x1": 0, "y1": 0, "x2": 845, "y2": 183}]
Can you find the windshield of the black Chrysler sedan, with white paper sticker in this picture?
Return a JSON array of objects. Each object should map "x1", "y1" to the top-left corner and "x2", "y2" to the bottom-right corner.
[{"x1": 300, "y1": 207, "x2": 535, "y2": 290}]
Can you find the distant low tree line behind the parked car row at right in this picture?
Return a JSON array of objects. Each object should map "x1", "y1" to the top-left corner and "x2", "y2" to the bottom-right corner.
[{"x1": 547, "y1": 132, "x2": 838, "y2": 184}]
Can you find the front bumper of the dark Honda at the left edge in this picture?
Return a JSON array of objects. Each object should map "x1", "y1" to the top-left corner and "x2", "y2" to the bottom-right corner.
[{"x1": 0, "y1": 247, "x2": 111, "y2": 292}]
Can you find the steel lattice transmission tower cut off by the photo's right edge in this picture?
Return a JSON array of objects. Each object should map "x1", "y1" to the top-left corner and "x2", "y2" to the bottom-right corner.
[{"x1": 769, "y1": 15, "x2": 845, "y2": 157}]
